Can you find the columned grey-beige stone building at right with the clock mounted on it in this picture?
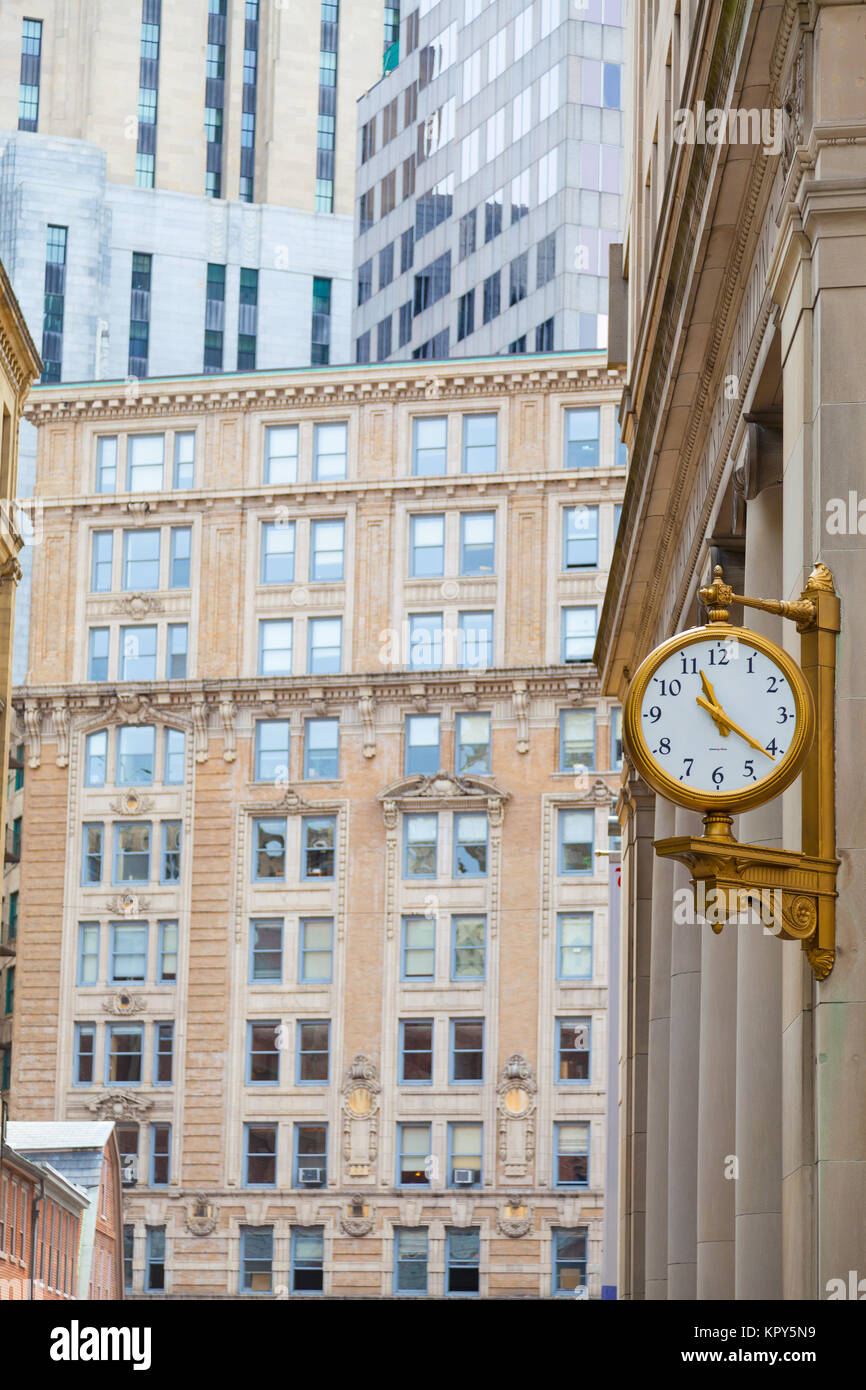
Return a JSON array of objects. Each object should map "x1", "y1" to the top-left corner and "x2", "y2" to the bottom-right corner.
[{"x1": 596, "y1": 0, "x2": 866, "y2": 1300}]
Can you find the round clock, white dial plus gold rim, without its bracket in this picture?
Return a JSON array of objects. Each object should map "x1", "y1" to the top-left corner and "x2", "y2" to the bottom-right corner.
[{"x1": 624, "y1": 624, "x2": 813, "y2": 810}]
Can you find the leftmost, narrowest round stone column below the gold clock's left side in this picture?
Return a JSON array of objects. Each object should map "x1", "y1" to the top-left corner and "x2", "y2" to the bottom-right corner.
[{"x1": 646, "y1": 796, "x2": 674, "y2": 1298}]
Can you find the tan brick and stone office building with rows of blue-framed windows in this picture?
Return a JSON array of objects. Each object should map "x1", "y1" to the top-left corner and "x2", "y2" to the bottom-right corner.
[{"x1": 13, "y1": 353, "x2": 624, "y2": 1297}]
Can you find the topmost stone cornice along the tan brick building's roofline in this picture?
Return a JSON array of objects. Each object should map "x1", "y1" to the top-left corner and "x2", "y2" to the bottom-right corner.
[{"x1": 25, "y1": 353, "x2": 623, "y2": 425}]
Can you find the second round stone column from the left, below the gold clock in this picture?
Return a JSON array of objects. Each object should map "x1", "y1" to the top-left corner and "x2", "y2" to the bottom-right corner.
[{"x1": 667, "y1": 809, "x2": 702, "y2": 1300}]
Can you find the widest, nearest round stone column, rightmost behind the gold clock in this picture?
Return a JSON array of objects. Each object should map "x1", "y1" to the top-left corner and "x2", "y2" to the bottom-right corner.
[{"x1": 734, "y1": 485, "x2": 784, "y2": 1298}]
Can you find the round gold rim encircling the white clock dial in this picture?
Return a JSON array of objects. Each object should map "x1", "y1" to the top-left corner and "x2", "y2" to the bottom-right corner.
[{"x1": 623, "y1": 623, "x2": 815, "y2": 815}]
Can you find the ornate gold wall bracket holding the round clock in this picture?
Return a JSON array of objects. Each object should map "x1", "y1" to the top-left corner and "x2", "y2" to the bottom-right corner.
[{"x1": 655, "y1": 563, "x2": 841, "y2": 980}]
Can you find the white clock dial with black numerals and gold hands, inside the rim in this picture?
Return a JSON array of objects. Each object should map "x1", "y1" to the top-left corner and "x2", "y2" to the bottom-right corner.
[{"x1": 639, "y1": 631, "x2": 798, "y2": 802}]
